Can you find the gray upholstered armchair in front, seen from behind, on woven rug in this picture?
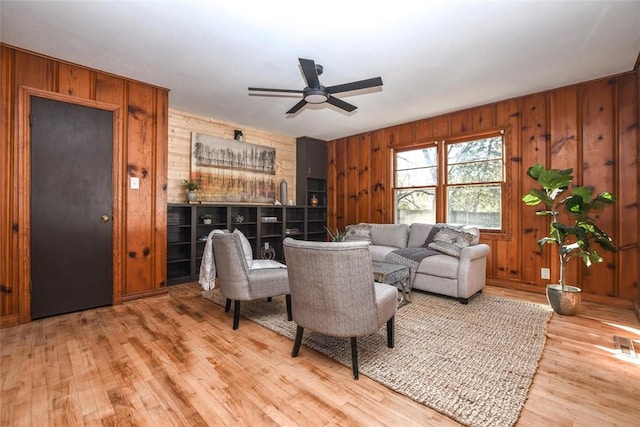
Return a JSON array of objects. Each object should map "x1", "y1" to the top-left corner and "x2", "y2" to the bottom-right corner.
[{"x1": 284, "y1": 238, "x2": 398, "y2": 379}]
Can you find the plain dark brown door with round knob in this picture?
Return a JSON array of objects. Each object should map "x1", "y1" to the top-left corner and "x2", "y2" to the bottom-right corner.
[{"x1": 31, "y1": 97, "x2": 113, "y2": 319}]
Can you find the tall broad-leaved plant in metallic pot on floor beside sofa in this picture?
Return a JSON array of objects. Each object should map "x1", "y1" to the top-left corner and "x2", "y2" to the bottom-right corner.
[{"x1": 522, "y1": 164, "x2": 617, "y2": 315}]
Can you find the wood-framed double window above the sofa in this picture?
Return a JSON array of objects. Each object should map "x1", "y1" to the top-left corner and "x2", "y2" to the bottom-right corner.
[{"x1": 394, "y1": 133, "x2": 505, "y2": 230}]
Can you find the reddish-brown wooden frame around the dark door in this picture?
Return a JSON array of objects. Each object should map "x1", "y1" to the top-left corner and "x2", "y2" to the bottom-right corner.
[{"x1": 14, "y1": 86, "x2": 126, "y2": 323}]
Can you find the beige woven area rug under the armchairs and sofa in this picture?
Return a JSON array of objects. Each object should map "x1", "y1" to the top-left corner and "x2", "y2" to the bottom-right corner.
[{"x1": 202, "y1": 289, "x2": 552, "y2": 426}]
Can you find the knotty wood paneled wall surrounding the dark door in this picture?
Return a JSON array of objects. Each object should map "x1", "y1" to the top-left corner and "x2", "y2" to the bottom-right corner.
[{"x1": 0, "y1": 45, "x2": 168, "y2": 326}]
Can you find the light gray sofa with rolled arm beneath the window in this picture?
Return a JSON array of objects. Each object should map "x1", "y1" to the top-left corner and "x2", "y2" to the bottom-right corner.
[{"x1": 347, "y1": 223, "x2": 490, "y2": 304}]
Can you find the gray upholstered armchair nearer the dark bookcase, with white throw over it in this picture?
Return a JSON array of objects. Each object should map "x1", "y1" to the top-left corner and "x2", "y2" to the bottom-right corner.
[{"x1": 211, "y1": 233, "x2": 292, "y2": 329}]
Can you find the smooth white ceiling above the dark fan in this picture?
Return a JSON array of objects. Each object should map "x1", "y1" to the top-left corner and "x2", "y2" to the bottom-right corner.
[{"x1": 0, "y1": 0, "x2": 640, "y2": 140}]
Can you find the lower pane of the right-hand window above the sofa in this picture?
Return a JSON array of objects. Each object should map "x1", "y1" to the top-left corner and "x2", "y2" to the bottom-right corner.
[{"x1": 447, "y1": 185, "x2": 502, "y2": 230}]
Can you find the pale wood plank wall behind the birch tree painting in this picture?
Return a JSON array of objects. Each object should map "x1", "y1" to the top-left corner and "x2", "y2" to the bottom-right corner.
[{"x1": 167, "y1": 109, "x2": 296, "y2": 203}]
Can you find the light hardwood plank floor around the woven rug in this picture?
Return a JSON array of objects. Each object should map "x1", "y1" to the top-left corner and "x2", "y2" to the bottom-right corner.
[{"x1": 0, "y1": 284, "x2": 640, "y2": 426}]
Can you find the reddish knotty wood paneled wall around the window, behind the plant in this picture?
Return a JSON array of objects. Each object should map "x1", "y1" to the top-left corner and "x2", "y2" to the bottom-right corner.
[{"x1": 329, "y1": 72, "x2": 640, "y2": 306}]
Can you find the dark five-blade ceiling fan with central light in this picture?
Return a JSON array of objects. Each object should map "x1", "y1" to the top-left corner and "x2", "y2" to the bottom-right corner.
[{"x1": 249, "y1": 58, "x2": 382, "y2": 114}]
